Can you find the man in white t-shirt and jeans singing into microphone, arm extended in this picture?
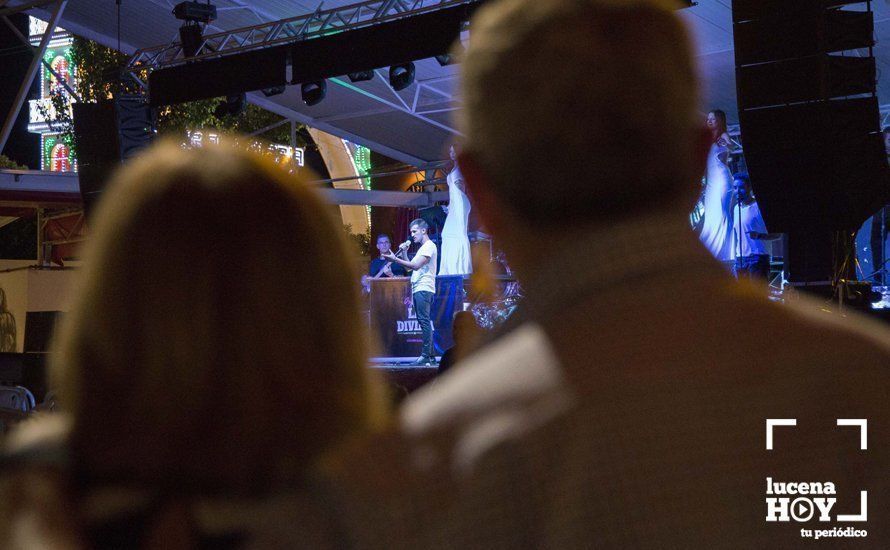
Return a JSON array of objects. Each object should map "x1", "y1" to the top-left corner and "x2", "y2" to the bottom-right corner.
[{"x1": 383, "y1": 218, "x2": 439, "y2": 365}]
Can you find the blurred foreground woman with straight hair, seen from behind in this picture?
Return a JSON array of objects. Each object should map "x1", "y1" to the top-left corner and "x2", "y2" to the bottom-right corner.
[{"x1": 0, "y1": 144, "x2": 382, "y2": 548}]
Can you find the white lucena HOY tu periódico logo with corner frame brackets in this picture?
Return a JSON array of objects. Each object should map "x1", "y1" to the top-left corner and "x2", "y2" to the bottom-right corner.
[{"x1": 766, "y1": 418, "x2": 868, "y2": 539}]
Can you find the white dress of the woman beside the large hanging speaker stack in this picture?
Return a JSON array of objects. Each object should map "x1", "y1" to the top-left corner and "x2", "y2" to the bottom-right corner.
[{"x1": 699, "y1": 143, "x2": 734, "y2": 261}]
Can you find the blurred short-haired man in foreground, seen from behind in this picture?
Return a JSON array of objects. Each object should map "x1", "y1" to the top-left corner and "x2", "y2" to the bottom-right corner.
[{"x1": 322, "y1": 0, "x2": 890, "y2": 549}]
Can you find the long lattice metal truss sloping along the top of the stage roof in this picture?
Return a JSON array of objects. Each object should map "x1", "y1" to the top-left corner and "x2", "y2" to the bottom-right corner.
[{"x1": 127, "y1": 0, "x2": 468, "y2": 72}]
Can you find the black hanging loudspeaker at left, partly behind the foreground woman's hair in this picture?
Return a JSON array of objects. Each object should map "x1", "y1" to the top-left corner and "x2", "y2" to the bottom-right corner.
[{"x1": 73, "y1": 96, "x2": 154, "y2": 216}]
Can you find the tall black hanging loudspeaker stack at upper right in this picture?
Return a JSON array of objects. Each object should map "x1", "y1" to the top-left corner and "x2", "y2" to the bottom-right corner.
[{"x1": 732, "y1": 0, "x2": 890, "y2": 282}]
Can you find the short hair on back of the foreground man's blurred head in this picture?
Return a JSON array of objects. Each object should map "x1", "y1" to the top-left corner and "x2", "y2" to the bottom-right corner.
[{"x1": 458, "y1": 0, "x2": 700, "y2": 225}]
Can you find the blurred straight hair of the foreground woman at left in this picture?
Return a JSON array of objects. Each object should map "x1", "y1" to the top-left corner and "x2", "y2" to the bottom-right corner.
[{"x1": 51, "y1": 143, "x2": 383, "y2": 493}]
